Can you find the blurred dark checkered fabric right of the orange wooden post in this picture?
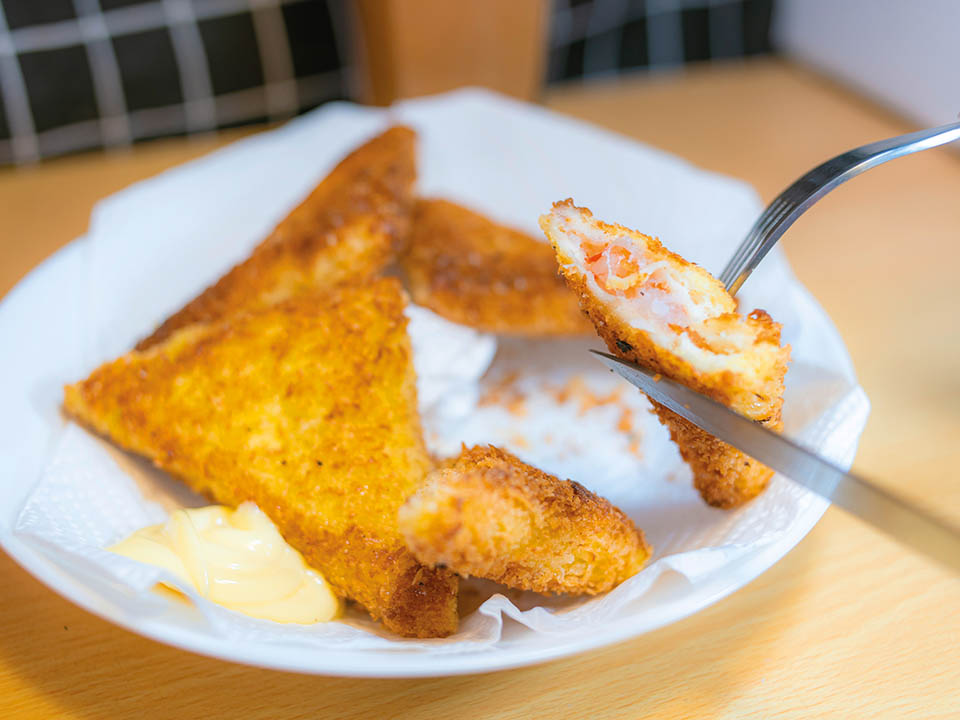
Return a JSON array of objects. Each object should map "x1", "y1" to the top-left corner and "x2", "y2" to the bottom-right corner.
[{"x1": 548, "y1": 0, "x2": 773, "y2": 82}]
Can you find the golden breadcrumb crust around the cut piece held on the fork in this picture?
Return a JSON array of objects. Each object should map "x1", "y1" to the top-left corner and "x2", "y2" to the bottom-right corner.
[{"x1": 541, "y1": 200, "x2": 790, "y2": 508}]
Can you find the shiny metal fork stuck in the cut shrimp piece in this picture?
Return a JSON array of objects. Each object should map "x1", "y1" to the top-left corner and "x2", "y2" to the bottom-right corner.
[{"x1": 719, "y1": 122, "x2": 960, "y2": 295}]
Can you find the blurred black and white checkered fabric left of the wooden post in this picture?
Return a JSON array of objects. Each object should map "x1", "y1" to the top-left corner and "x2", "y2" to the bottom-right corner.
[{"x1": 0, "y1": 0, "x2": 349, "y2": 164}]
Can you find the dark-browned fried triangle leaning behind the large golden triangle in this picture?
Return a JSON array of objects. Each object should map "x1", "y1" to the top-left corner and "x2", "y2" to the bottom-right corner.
[{"x1": 137, "y1": 126, "x2": 416, "y2": 350}]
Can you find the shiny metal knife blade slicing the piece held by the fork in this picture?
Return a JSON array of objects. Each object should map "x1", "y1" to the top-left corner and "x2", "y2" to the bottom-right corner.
[{"x1": 590, "y1": 350, "x2": 960, "y2": 573}]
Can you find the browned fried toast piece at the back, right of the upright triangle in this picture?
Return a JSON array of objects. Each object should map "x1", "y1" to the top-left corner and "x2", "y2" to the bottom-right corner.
[{"x1": 401, "y1": 200, "x2": 592, "y2": 336}]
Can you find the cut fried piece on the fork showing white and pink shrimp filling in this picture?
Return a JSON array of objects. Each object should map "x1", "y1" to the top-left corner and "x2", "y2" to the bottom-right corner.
[{"x1": 540, "y1": 200, "x2": 790, "y2": 508}]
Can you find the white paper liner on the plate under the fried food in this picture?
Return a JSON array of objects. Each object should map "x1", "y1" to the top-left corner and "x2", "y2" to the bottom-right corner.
[{"x1": 16, "y1": 91, "x2": 868, "y2": 653}]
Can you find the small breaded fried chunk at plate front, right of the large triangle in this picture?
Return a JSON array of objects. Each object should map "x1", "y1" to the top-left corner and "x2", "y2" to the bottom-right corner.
[{"x1": 399, "y1": 446, "x2": 651, "y2": 595}]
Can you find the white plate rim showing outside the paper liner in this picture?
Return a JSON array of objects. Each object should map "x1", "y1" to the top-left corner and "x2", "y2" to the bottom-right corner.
[{"x1": 0, "y1": 107, "x2": 862, "y2": 679}]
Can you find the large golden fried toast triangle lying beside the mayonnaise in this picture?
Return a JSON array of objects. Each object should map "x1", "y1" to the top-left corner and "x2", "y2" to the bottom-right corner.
[{"x1": 64, "y1": 279, "x2": 458, "y2": 637}]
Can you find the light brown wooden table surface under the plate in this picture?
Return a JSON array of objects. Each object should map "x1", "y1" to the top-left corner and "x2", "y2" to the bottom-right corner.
[{"x1": 0, "y1": 60, "x2": 960, "y2": 720}]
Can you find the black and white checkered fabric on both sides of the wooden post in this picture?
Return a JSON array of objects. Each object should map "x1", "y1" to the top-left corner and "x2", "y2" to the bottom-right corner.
[{"x1": 0, "y1": 0, "x2": 773, "y2": 165}]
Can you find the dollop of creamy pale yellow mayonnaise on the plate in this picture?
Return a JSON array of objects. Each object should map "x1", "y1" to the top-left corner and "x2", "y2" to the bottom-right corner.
[{"x1": 109, "y1": 503, "x2": 341, "y2": 625}]
